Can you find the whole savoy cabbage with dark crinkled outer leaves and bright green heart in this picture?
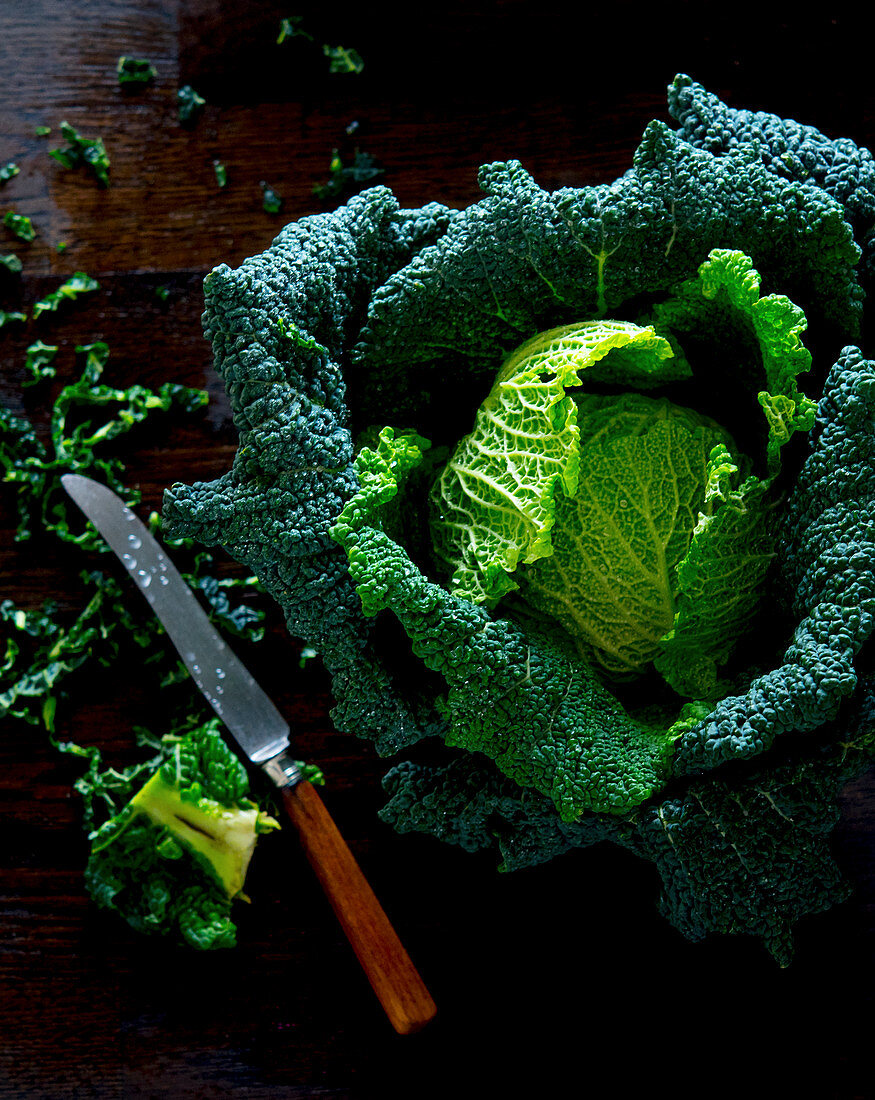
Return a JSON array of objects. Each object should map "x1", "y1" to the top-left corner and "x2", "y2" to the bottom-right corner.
[{"x1": 164, "y1": 76, "x2": 875, "y2": 963}]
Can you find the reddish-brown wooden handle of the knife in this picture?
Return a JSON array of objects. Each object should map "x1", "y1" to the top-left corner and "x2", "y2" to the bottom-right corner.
[{"x1": 283, "y1": 780, "x2": 437, "y2": 1035}]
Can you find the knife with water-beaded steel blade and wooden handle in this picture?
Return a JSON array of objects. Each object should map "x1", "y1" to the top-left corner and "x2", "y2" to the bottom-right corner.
[{"x1": 61, "y1": 474, "x2": 437, "y2": 1035}]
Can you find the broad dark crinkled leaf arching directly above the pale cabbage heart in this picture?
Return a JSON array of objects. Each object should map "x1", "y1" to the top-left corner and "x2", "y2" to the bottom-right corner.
[{"x1": 356, "y1": 122, "x2": 862, "y2": 413}]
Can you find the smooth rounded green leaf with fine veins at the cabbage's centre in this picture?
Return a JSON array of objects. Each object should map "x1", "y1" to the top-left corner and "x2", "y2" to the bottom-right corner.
[{"x1": 517, "y1": 394, "x2": 726, "y2": 674}]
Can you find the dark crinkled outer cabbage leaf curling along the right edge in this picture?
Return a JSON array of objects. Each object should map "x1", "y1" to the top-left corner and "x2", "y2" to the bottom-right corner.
[{"x1": 675, "y1": 348, "x2": 875, "y2": 774}]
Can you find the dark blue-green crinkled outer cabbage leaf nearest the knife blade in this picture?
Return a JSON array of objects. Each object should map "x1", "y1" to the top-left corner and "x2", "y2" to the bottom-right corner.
[{"x1": 164, "y1": 188, "x2": 464, "y2": 751}]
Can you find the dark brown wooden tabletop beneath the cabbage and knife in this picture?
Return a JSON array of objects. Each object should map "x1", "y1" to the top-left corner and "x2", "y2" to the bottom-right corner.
[{"x1": 0, "y1": 0, "x2": 875, "y2": 1100}]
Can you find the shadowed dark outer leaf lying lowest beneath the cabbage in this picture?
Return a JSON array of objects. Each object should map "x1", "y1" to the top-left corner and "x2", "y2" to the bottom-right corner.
[{"x1": 381, "y1": 681, "x2": 875, "y2": 965}]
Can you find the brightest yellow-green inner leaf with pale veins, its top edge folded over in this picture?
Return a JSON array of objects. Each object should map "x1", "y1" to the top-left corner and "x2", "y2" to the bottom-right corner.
[{"x1": 431, "y1": 321, "x2": 688, "y2": 602}]
